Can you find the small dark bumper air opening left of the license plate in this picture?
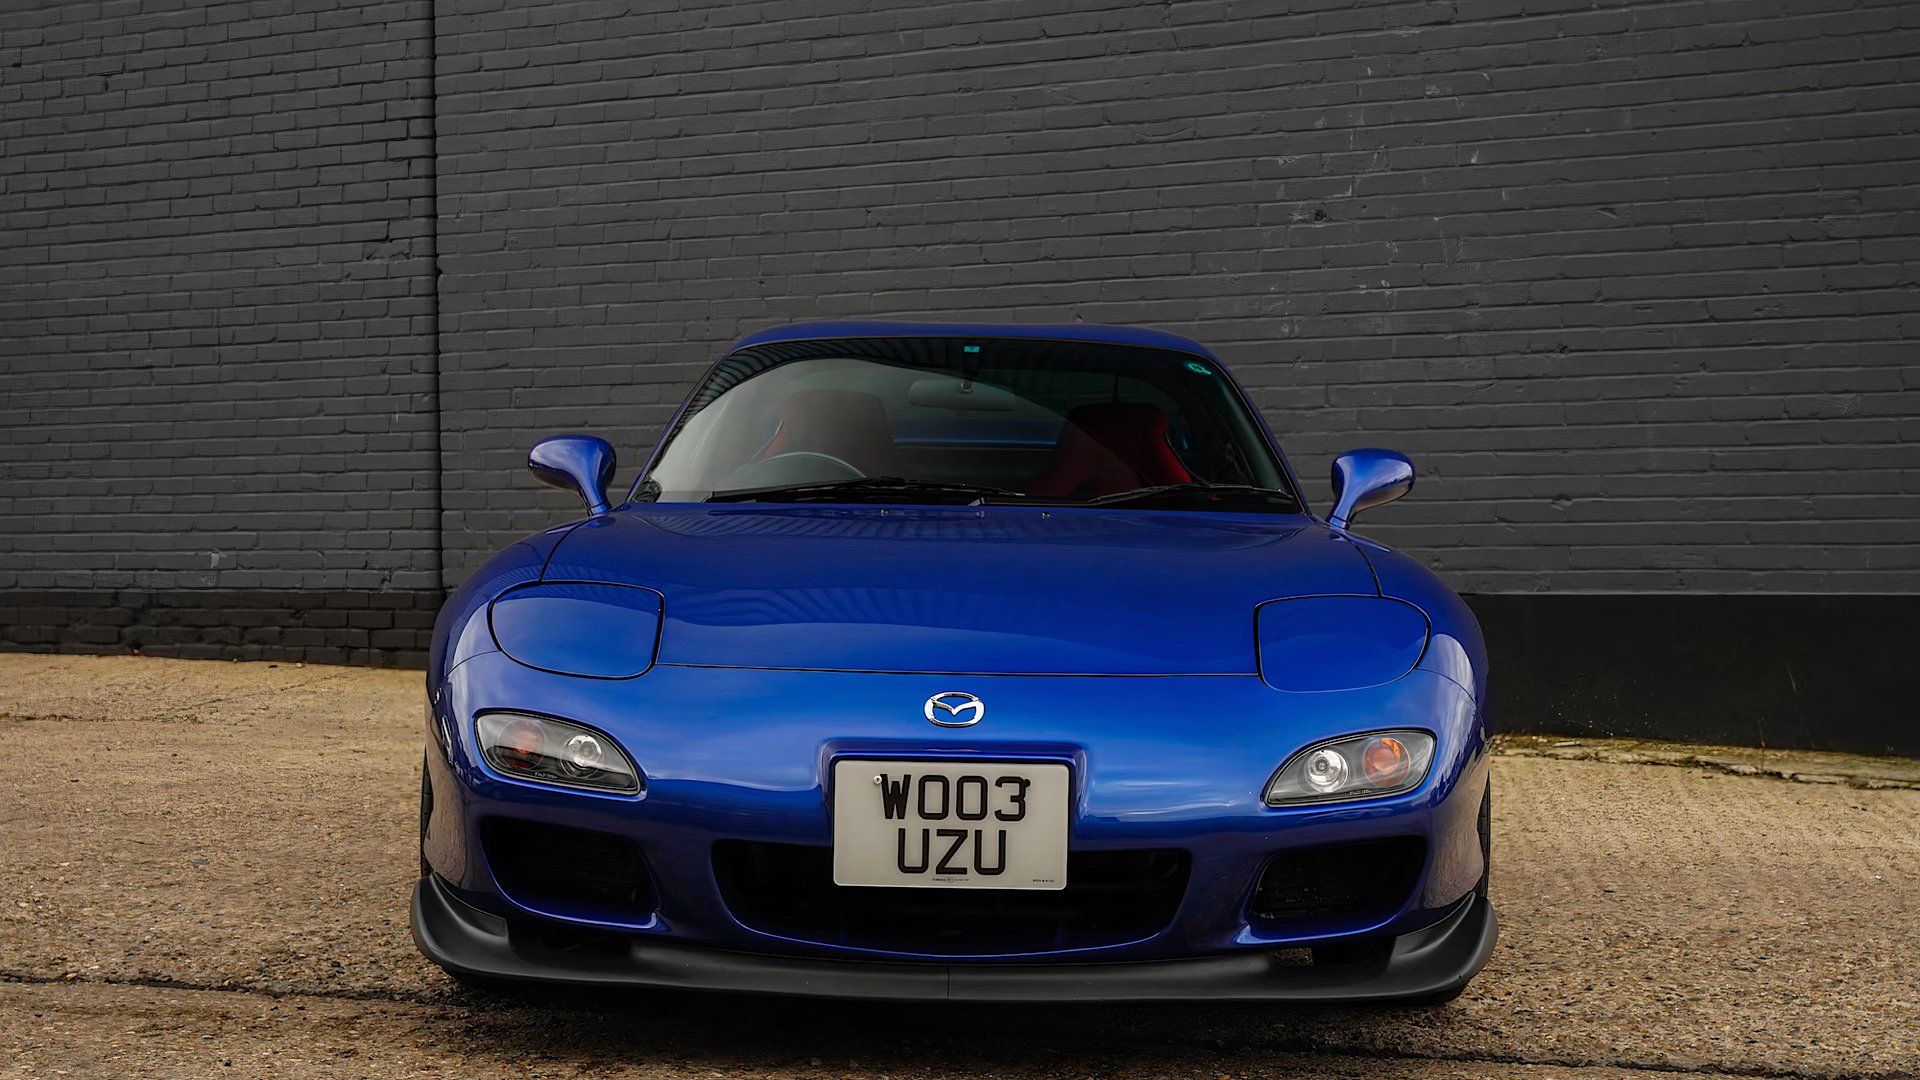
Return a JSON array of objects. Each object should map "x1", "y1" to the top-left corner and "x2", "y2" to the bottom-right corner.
[{"x1": 480, "y1": 817, "x2": 655, "y2": 920}]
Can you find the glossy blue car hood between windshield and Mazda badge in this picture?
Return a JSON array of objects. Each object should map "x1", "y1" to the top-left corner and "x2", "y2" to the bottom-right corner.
[{"x1": 543, "y1": 503, "x2": 1377, "y2": 675}]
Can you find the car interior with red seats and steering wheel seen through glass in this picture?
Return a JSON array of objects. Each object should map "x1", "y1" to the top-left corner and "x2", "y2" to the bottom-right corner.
[{"x1": 655, "y1": 340, "x2": 1271, "y2": 502}]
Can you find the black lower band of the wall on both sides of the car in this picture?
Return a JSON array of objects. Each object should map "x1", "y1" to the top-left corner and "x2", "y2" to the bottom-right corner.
[{"x1": 0, "y1": 590, "x2": 1920, "y2": 757}]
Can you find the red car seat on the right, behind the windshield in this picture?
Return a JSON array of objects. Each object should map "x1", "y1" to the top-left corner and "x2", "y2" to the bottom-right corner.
[{"x1": 1027, "y1": 402, "x2": 1192, "y2": 498}]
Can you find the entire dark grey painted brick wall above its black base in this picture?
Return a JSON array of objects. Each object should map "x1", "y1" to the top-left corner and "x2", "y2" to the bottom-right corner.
[{"x1": 0, "y1": 0, "x2": 1920, "y2": 595}]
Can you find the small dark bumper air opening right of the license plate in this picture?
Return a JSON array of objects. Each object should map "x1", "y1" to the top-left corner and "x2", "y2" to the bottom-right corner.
[{"x1": 1252, "y1": 836, "x2": 1427, "y2": 922}]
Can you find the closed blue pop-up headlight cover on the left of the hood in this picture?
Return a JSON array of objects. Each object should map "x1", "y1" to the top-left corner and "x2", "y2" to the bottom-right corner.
[{"x1": 488, "y1": 580, "x2": 660, "y2": 678}]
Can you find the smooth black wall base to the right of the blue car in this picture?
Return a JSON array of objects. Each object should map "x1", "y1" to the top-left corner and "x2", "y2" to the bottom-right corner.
[{"x1": 1467, "y1": 594, "x2": 1920, "y2": 757}]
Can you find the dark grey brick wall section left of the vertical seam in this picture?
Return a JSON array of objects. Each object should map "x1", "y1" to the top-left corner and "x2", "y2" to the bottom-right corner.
[{"x1": 0, "y1": 0, "x2": 438, "y2": 588}]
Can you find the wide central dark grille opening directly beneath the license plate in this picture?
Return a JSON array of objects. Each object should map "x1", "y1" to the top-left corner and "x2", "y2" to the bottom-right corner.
[{"x1": 714, "y1": 840, "x2": 1190, "y2": 957}]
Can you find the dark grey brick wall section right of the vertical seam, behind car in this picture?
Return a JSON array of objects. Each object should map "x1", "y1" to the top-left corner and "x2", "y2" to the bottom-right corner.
[{"x1": 438, "y1": 0, "x2": 1920, "y2": 592}]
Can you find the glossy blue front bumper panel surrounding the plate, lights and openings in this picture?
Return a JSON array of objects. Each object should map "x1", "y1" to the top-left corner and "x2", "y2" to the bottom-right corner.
[{"x1": 420, "y1": 653, "x2": 1486, "y2": 980}]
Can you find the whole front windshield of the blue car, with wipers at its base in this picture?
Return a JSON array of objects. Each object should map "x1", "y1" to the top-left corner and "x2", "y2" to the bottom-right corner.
[{"x1": 641, "y1": 338, "x2": 1298, "y2": 513}]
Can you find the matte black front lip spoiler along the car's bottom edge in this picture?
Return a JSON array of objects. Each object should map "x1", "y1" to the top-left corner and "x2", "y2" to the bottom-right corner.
[{"x1": 413, "y1": 876, "x2": 1496, "y2": 1001}]
